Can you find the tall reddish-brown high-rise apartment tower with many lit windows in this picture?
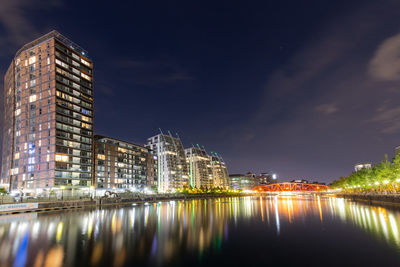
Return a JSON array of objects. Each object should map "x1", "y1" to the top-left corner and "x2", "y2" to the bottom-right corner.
[{"x1": 0, "y1": 31, "x2": 93, "y2": 191}]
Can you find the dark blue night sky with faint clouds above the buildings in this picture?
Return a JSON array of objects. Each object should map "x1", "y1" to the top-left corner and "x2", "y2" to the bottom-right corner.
[{"x1": 0, "y1": 0, "x2": 400, "y2": 182}]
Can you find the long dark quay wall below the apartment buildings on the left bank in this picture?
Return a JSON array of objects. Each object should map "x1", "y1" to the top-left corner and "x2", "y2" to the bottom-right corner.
[{"x1": 0, "y1": 194, "x2": 254, "y2": 217}]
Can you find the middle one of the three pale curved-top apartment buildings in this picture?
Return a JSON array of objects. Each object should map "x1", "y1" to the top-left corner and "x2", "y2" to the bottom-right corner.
[{"x1": 185, "y1": 146, "x2": 214, "y2": 188}]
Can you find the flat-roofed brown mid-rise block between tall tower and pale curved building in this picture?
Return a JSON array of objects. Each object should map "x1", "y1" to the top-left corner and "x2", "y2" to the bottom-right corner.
[{"x1": 94, "y1": 135, "x2": 157, "y2": 191}]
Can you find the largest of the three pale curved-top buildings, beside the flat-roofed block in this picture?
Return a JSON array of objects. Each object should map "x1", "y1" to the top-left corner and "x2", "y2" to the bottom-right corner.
[{"x1": 146, "y1": 133, "x2": 189, "y2": 192}]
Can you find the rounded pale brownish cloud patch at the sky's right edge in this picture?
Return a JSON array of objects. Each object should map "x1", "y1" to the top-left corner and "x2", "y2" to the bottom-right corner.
[{"x1": 369, "y1": 34, "x2": 400, "y2": 81}]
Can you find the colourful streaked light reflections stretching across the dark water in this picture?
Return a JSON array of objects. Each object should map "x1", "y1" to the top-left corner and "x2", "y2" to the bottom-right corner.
[{"x1": 0, "y1": 196, "x2": 400, "y2": 266}]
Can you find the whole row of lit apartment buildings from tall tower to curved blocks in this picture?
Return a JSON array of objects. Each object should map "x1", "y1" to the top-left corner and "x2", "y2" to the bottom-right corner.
[{"x1": 0, "y1": 31, "x2": 228, "y2": 195}]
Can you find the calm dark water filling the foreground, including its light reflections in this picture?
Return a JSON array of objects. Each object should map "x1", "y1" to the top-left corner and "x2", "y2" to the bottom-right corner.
[{"x1": 0, "y1": 196, "x2": 400, "y2": 266}]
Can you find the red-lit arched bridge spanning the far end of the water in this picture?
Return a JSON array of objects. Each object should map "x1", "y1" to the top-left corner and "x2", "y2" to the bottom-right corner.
[{"x1": 253, "y1": 183, "x2": 329, "y2": 193}]
